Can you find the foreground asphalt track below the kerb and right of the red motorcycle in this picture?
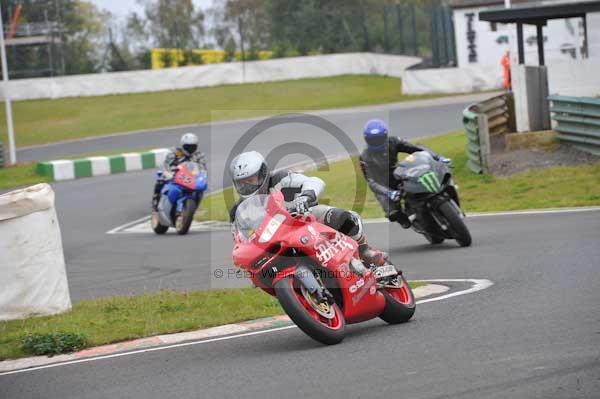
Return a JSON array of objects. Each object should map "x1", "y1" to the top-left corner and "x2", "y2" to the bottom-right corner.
[{"x1": 0, "y1": 211, "x2": 600, "y2": 399}]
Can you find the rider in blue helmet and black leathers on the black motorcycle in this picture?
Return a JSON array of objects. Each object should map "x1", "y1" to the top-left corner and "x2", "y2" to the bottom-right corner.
[{"x1": 360, "y1": 119, "x2": 445, "y2": 229}]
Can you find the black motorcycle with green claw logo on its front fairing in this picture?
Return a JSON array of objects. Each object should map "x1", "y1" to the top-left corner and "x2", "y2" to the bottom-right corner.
[{"x1": 394, "y1": 151, "x2": 471, "y2": 247}]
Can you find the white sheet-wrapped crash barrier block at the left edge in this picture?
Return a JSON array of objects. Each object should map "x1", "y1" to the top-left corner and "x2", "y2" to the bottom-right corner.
[{"x1": 0, "y1": 184, "x2": 71, "y2": 320}]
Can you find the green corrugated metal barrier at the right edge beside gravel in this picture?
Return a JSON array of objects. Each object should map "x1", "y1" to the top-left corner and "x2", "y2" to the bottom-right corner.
[{"x1": 548, "y1": 96, "x2": 600, "y2": 155}]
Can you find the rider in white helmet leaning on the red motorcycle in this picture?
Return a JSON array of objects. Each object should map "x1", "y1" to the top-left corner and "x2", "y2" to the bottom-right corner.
[{"x1": 229, "y1": 151, "x2": 387, "y2": 266}]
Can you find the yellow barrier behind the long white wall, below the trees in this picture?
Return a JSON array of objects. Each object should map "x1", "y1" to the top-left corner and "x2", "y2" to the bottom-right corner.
[{"x1": 151, "y1": 48, "x2": 273, "y2": 69}]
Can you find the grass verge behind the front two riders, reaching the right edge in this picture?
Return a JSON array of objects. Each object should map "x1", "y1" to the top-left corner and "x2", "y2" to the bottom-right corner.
[{"x1": 197, "y1": 130, "x2": 600, "y2": 220}]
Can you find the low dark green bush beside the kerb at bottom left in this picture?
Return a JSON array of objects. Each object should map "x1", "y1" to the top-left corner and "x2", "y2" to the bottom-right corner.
[{"x1": 21, "y1": 332, "x2": 88, "y2": 356}]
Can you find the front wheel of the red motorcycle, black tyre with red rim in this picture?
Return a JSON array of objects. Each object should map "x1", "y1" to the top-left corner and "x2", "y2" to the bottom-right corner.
[{"x1": 275, "y1": 277, "x2": 346, "y2": 345}]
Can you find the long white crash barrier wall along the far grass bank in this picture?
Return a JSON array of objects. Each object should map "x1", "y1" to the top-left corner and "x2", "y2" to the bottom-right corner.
[{"x1": 0, "y1": 53, "x2": 421, "y2": 100}]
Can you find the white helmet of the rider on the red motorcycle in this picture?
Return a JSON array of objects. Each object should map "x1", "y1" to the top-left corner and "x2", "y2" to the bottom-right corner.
[{"x1": 229, "y1": 151, "x2": 269, "y2": 199}]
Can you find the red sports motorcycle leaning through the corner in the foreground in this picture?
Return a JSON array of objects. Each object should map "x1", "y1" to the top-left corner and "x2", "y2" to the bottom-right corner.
[{"x1": 233, "y1": 192, "x2": 416, "y2": 345}]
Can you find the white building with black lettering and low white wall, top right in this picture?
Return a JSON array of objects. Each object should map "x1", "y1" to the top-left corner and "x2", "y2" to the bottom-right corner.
[{"x1": 403, "y1": 0, "x2": 600, "y2": 97}]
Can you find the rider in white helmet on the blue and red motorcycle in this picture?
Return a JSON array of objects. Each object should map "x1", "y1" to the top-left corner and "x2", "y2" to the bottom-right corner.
[{"x1": 152, "y1": 133, "x2": 206, "y2": 210}]
